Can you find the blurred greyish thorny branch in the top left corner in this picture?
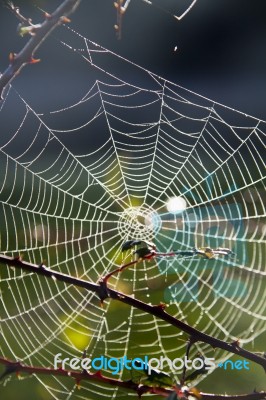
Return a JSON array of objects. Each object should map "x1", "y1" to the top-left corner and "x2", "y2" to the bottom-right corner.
[{"x1": 0, "y1": 0, "x2": 81, "y2": 100}]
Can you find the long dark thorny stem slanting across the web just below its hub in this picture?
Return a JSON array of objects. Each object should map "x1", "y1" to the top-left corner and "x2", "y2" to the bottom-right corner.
[{"x1": 0, "y1": 255, "x2": 266, "y2": 371}]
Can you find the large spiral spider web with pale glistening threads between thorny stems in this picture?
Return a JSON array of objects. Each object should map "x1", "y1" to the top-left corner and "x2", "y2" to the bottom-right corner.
[{"x1": 0, "y1": 24, "x2": 266, "y2": 399}]
